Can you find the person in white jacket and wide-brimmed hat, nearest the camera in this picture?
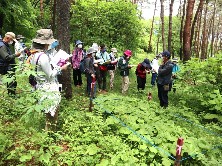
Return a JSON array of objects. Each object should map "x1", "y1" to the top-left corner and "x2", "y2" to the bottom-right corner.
[{"x1": 30, "y1": 29, "x2": 69, "y2": 131}]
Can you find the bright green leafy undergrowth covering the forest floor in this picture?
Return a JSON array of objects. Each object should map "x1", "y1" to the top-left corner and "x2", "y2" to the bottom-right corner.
[{"x1": 0, "y1": 53, "x2": 222, "y2": 166}]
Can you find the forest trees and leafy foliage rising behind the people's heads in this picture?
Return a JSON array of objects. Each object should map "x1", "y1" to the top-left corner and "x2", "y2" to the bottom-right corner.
[{"x1": 0, "y1": 0, "x2": 222, "y2": 61}]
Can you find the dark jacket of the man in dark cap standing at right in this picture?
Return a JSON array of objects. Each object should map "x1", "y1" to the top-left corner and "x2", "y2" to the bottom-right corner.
[{"x1": 157, "y1": 60, "x2": 173, "y2": 85}]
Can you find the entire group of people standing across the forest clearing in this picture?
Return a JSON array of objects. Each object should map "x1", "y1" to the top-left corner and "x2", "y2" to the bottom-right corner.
[{"x1": 0, "y1": 29, "x2": 178, "y2": 130}]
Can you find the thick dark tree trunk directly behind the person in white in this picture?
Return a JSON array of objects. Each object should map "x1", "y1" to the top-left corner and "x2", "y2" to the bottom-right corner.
[{"x1": 57, "y1": 0, "x2": 72, "y2": 99}]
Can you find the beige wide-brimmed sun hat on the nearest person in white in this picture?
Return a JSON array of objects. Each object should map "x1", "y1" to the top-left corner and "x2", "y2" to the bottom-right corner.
[{"x1": 32, "y1": 29, "x2": 57, "y2": 44}]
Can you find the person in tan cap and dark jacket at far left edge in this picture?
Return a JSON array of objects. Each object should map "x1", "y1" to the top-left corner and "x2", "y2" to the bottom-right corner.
[{"x1": 0, "y1": 32, "x2": 21, "y2": 95}]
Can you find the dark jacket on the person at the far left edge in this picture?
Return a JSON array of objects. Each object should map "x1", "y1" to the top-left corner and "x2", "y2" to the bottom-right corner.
[{"x1": 0, "y1": 40, "x2": 15, "y2": 74}]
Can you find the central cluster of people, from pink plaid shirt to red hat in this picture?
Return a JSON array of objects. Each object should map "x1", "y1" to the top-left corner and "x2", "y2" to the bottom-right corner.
[{"x1": 72, "y1": 40, "x2": 132, "y2": 97}]
